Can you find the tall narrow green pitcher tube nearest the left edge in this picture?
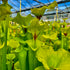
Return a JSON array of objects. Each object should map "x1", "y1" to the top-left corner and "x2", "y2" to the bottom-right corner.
[{"x1": 1, "y1": 21, "x2": 8, "y2": 70}]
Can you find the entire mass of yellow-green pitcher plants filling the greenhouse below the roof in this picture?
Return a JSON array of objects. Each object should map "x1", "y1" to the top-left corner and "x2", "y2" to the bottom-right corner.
[{"x1": 0, "y1": 0, "x2": 70, "y2": 70}]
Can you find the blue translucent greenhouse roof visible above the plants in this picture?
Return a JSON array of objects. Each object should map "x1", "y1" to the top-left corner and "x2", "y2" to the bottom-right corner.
[{"x1": 0, "y1": 0, "x2": 70, "y2": 15}]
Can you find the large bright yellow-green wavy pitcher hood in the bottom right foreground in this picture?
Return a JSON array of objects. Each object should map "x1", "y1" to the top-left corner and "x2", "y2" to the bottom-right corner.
[{"x1": 36, "y1": 47, "x2": 70, "y2": 70}]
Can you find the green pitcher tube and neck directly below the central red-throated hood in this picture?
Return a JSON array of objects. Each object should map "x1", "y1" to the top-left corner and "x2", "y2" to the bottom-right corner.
[{"x1": 29, "y1": 40, "x2": 39, "y2": 70}]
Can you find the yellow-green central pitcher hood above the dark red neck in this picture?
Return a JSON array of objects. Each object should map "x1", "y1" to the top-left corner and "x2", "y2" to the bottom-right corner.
[{"x1": 28, "y1": 18, "x2": 43, "y2": 35}]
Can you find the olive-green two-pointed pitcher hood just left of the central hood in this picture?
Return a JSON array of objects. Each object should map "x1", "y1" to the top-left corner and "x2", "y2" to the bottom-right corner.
[{"x1": 12, "y1": 13, "x2": 33, "y2": 26}]
